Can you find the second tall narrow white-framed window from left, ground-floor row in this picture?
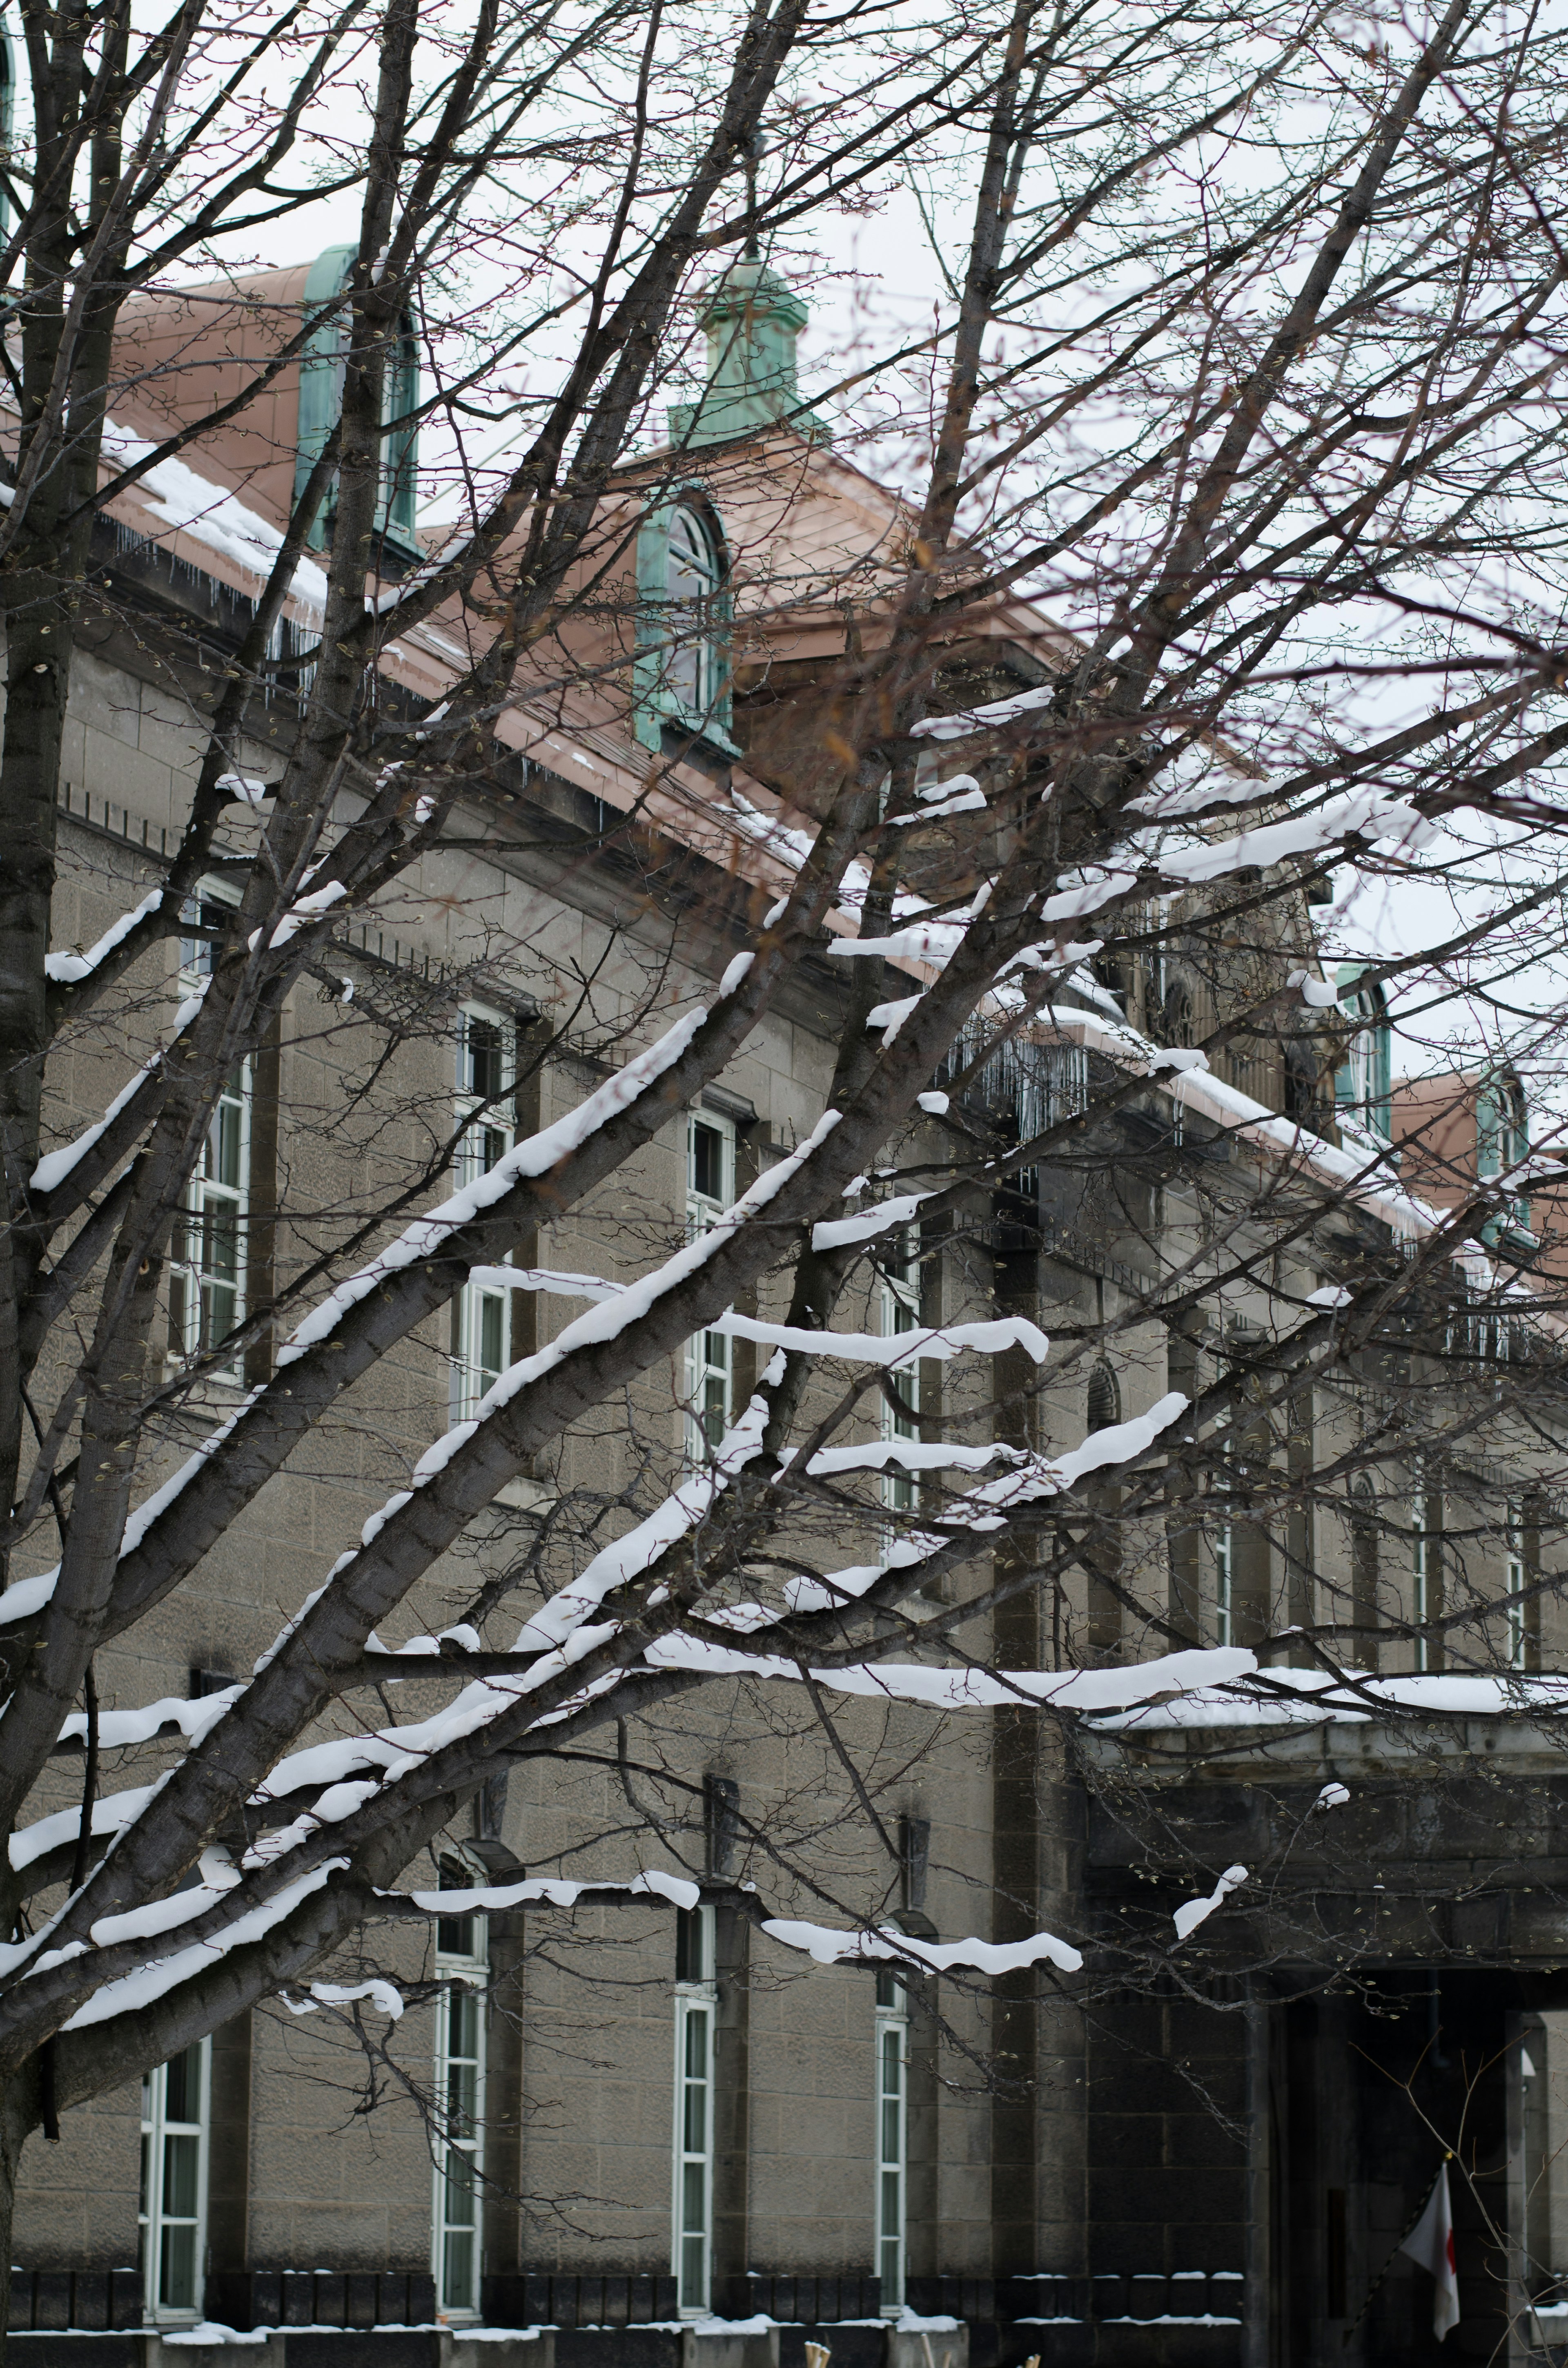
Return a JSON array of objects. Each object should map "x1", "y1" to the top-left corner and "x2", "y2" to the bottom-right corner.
[{"x1": 431, "y1": 1859, "x2": 488, "y2": 2318}]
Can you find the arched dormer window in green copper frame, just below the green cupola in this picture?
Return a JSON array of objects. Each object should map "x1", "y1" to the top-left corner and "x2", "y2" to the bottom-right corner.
[{"x1": 635, "y1": 497, "x2": 739, "y2": 753}]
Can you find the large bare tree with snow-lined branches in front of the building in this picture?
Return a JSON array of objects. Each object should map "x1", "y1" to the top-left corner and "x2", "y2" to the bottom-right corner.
[{"x1": 0, "y1": 0, "x2": 1568, "y2": 2301}]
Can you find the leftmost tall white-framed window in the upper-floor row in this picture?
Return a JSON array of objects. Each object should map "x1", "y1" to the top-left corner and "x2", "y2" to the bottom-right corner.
[{"x1": 168, "y1": 885, "x2": 254, "y2": 1380}]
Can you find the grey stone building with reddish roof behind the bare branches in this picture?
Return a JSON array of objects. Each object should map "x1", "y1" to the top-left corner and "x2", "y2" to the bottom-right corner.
[{"x1": 12, "y1": 253, "x2": 1568, "y2": 2368}]
